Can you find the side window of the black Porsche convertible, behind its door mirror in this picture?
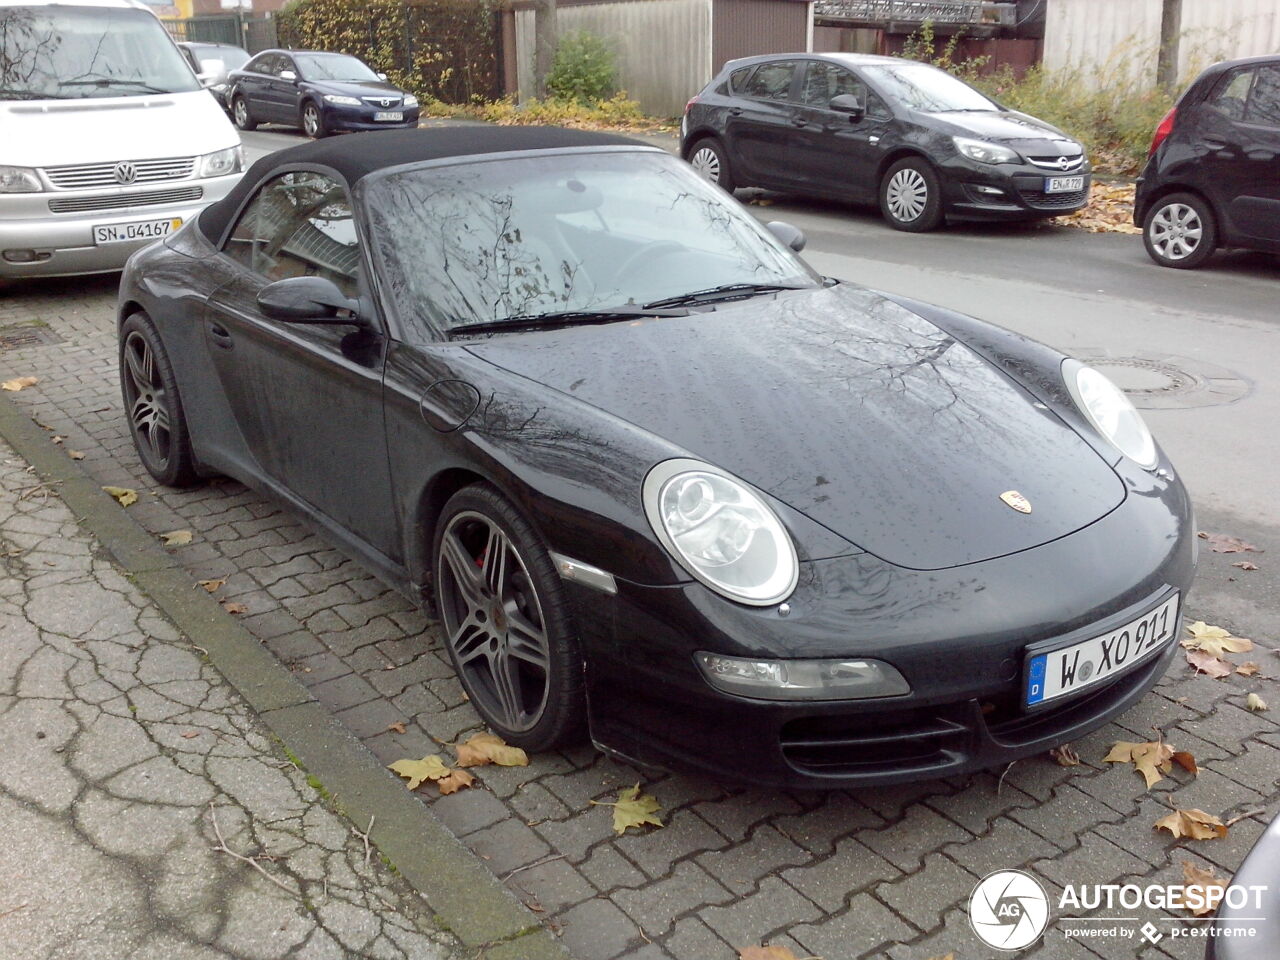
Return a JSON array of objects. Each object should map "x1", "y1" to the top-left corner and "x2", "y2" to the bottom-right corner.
[{"x1": 223, "y1": 170, "x2": 360, "y2": 297}]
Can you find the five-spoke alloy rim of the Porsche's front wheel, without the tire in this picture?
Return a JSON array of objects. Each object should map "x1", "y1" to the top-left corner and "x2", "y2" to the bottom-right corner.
[{"x1": 436, "y1": 511, "x2": 550, "y2": 731}]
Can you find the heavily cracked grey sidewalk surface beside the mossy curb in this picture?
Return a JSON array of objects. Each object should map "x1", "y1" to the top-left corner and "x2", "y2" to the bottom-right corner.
[{"x1": 0, "y1": 444, "x2": 457, "y2": 960}]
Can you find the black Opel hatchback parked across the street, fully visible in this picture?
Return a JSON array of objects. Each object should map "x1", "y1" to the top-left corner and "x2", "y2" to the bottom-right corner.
[{"x1": 681, "y1": 54, "x2": 1089, "y2": 232}]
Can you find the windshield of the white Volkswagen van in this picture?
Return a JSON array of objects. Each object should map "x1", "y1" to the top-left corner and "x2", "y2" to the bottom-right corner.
[{"x1": 0, "y1": 4, "x2": 200, "y2": 100}]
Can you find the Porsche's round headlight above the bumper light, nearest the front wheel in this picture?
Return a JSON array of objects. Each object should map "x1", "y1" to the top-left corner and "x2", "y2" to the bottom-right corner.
[{"x1": 643, "y1": 460, "x2": 800, "y2": 607}]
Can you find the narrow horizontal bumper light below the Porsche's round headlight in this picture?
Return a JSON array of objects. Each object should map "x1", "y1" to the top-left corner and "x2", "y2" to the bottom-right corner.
[{"x1": 696, "y1": 653, "x2": 911, "y2": 700}]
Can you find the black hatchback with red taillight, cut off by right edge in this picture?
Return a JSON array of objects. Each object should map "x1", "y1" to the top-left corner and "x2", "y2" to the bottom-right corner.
[{"x1": 1134, "y1": 56, "x2": 1280, "y2": 269}]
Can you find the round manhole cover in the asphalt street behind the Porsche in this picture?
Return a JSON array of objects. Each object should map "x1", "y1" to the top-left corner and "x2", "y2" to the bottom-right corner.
[{"x1": 1075, "y1": 348, "x2": 1253, "y2": 410}]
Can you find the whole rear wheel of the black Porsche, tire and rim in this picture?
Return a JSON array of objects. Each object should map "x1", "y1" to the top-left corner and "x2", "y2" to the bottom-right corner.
[{"x1": 119, "y1": 314, "x2": 200, "y2": 486}]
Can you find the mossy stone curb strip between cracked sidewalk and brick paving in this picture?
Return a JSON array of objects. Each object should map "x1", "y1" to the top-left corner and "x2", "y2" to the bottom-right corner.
[{"x1": 0, "y1": 397, "x2": 570, "y2": 960}]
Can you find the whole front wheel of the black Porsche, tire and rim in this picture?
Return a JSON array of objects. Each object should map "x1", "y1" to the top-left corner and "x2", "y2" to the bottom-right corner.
[{"x1": 431, "y1": 484, "x2": 586, "y2": 751}]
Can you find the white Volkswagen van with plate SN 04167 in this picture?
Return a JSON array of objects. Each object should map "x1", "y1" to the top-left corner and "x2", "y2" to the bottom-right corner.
[{"x1": 0, "y1": 0, "x2": 244, "y2": 278}]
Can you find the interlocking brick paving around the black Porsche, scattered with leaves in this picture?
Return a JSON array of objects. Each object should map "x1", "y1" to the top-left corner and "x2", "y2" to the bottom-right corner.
[{"x1": 0, "y1": 282, "x2": 1280, "y2": 960}]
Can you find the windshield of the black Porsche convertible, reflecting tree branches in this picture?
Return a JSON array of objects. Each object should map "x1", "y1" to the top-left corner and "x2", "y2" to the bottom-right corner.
[{"x1": 365, "y1": 151, "x2": 820, "y2": 338}]
